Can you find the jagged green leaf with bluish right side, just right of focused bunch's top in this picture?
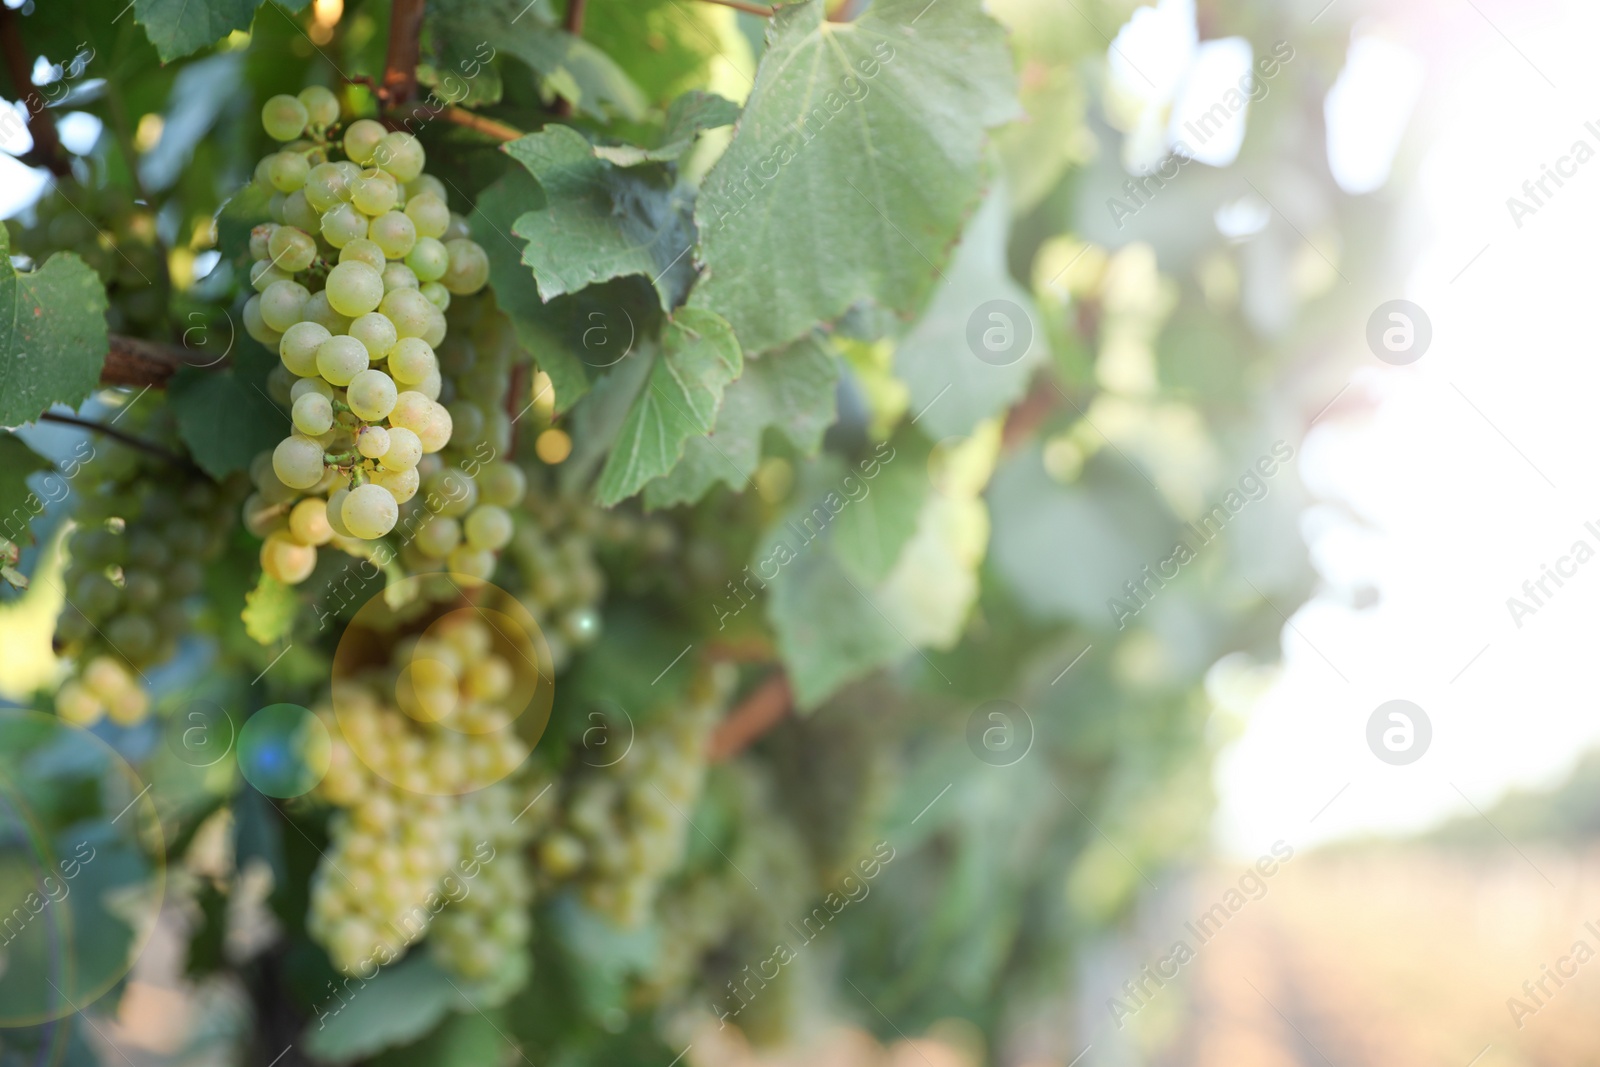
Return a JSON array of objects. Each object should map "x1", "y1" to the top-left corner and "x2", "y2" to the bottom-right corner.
[{"x1": 506, "y1": 126, "x2": 694, "y2": 309}]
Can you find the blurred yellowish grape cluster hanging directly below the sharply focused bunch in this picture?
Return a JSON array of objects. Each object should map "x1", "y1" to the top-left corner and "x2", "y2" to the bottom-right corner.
[{"x1": 307, "y1": 613, "x2": 536, "y2": 979}]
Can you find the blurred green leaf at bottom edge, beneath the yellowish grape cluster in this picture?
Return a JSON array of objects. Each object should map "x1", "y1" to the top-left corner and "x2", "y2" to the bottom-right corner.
[{"x1": 304, "y1": 952, "x2": 470, "y2": 1064}]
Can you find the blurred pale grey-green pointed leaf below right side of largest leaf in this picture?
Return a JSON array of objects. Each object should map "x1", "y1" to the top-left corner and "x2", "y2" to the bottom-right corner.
[{"x1": 894, "y1": 181, "x2": 1048, "y2": 438}]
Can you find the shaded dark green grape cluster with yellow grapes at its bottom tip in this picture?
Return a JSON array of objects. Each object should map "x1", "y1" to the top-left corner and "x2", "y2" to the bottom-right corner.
[{"x1": 54, "y1": 435, "x2": 238, "y2": 726}]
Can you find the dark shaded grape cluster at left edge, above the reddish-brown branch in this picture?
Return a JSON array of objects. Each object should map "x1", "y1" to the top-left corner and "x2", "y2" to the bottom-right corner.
[{"x1": 8, "y1": 179, "x2": 168, "y2": 336}]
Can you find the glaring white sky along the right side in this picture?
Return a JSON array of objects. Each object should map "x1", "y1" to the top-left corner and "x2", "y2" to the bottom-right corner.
[{"x1": 1216, "y1": 0, "x2": 1600, "y2": 856}]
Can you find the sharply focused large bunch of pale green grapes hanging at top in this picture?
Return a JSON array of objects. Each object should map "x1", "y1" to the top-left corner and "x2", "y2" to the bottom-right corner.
[{"x1": 245, "y1": 86, "x2": 488, "y2": 584}]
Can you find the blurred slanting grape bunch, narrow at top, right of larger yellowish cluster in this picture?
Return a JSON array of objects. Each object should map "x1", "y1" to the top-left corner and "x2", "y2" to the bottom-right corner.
[{"x1": 536, "y1": 664, "x2": 734, "y2": 926}]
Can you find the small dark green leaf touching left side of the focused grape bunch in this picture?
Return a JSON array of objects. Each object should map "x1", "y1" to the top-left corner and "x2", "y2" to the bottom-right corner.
[{"x1": 166, "y1": 365, "x2": 290, "y2": 478}]
